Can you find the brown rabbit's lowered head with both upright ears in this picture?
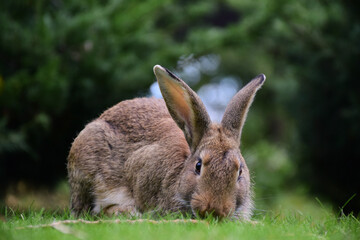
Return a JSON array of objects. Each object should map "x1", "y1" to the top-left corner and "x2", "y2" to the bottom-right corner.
[{"x1": 154, "y1": 65, "x2": 265, "y2": 219}]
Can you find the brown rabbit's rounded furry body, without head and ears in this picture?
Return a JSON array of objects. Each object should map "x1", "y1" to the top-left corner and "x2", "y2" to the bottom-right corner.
[{"x1": 68, "y1": 98, "x2": 190, "y2": 213}]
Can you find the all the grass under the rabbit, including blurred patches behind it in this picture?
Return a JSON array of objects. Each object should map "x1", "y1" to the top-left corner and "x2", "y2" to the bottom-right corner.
[{"x1": 0, "y1": 183, "x2": 360, "y2": 240}]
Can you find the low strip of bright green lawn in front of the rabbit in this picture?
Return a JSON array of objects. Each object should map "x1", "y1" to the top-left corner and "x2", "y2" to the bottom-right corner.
[{"x1": 0, "y1": 208, "x2": 360, "y2": 240}]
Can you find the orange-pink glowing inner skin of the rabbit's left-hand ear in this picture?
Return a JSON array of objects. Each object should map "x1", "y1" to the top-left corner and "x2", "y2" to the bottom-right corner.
[{"x1": 165, "y1": 81, "x2": 192, "y2": 126}]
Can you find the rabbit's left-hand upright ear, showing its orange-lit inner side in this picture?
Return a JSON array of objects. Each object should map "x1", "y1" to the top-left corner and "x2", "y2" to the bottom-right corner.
[{"x1": 154, "y1": 65, "x2": 211, "y2": 152}]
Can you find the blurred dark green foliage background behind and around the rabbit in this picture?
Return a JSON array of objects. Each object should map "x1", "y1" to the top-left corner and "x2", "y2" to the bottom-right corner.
[{"x1": 0, "y1": 0, "x2": 360, "y2": 217}]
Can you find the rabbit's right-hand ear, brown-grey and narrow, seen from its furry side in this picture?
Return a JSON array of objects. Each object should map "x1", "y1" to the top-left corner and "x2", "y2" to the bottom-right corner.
[{"x1": 221, "y1": 74, "x2": 266, "y2": 143}]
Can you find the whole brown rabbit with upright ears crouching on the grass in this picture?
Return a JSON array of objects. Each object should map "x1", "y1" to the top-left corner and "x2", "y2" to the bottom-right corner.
[{"x1": 68, "y1": 65, "x2": 265, "y2": 220}]
